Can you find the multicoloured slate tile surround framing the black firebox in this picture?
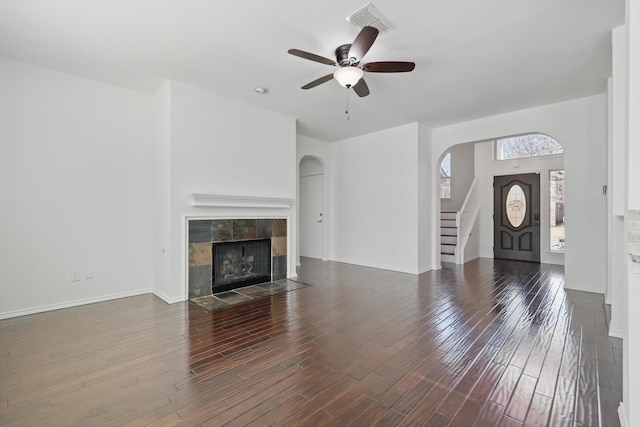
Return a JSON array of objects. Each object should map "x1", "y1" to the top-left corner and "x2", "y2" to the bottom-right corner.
[{"x1": 188, "y1": 218, "x2": 287, "y2": 298}]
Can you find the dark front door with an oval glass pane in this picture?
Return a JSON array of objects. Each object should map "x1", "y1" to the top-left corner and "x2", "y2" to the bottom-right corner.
[{"x1": 493, "y1": 173, "x2": 540, "y2": 262}]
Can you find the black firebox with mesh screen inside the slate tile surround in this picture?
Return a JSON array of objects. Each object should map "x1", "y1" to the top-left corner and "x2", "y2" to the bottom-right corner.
[{"x1": 211, "y1": 239, "x2": 271, "y2": 293}]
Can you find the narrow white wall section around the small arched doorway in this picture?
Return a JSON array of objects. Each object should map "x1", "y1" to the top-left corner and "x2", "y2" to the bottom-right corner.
[{"x1": 296, "y1": 135, "x2": 333, "y2": 265}]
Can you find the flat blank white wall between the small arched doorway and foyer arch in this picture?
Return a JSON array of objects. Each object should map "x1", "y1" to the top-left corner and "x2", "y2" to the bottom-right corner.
[{"x1": 330, "y1": 123, "x2": 419, "y2": 273}]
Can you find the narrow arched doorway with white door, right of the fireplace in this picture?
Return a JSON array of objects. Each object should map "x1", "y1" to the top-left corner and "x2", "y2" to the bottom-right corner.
[{"x1": 300, "y1": 156, "x2": 324, "y2": 259}]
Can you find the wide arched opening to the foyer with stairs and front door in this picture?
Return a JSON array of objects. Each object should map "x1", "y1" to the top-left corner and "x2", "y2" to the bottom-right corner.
[{"x1": 434, "y1": 133, "x2": 565, "y2": 265}]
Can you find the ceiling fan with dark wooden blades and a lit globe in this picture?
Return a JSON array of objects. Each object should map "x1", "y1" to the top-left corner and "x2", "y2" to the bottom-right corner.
[{"x1": 287, "y1": 26, "x2": 416, "y2": 97}]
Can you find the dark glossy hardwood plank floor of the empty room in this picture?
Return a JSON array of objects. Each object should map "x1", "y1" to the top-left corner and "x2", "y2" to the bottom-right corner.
[{"x1": 0, "y1": 259, "x2": 622, "y2": 427}]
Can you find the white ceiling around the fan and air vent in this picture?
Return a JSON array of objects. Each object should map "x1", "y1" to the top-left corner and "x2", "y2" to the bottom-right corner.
[{"x1": 0, "y1": 0, "x2": 624, "y2": 141}]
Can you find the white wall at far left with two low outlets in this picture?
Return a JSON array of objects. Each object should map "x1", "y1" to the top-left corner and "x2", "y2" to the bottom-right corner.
[{"x1": 0, "y1": 58, "x2": 153, "y2": 317}]
